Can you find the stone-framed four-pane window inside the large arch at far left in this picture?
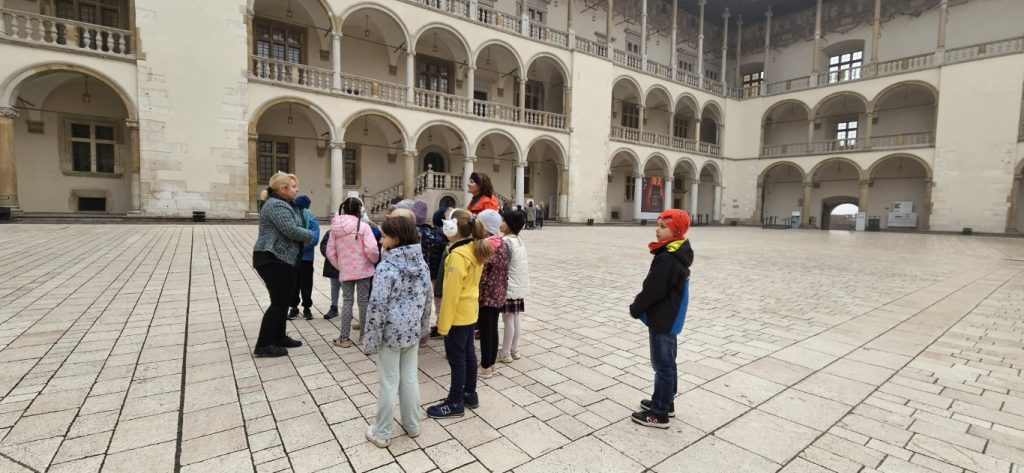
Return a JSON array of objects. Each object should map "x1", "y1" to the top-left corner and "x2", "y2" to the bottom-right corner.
[{"x1": 58, "y1": 115, "x2": 125, "y2": 179}]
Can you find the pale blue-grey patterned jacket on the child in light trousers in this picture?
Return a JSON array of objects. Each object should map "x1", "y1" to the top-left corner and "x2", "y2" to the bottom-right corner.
[{"x1": 362, "y1": 245, "x2": 433, "y2": 354}]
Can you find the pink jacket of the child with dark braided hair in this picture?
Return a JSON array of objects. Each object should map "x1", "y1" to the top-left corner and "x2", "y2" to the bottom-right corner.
[{"x1": 327, "y1": 215, "x2": 381, "y2": 281}]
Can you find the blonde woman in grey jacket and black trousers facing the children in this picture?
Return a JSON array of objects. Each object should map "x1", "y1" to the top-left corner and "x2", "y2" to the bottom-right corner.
[{"x1": 253, "y1": 172, "x2": 313, "y2": 356}]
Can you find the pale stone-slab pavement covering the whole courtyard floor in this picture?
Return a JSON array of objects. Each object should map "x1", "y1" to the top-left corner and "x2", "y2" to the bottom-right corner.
[{"x1": 0, "y1": 224, "x2": 1024, "y2": 473}]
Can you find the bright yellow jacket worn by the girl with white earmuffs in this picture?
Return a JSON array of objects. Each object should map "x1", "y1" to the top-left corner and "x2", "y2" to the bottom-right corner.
[{"x1": 437, "y1": 240, "x2": 483, "y2": 335}]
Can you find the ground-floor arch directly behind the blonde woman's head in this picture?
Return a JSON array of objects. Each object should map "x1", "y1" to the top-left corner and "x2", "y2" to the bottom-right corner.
[{"x1": 249, "y1": 99, "x2": 333, "y2": 215}]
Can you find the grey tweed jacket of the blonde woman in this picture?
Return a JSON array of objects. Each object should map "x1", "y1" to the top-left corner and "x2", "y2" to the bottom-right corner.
[{"x1": 253, "y1": 194, "x2": 313, "y2": 266}]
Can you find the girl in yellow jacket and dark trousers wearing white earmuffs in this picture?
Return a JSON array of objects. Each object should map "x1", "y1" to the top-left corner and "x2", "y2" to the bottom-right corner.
[{"x1": 427, "y1": 209, "x2": 495, "y2": 419}]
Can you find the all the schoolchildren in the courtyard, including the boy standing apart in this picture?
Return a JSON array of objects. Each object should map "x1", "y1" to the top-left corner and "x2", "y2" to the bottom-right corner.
[{"x1": 280, "y1": 192, "x2": 693, "y2": 447}]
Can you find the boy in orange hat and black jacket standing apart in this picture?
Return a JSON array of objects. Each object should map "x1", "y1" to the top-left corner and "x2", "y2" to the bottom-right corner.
[{"x1": 630, "y1": 209, "x2": 693, "y2": 429}]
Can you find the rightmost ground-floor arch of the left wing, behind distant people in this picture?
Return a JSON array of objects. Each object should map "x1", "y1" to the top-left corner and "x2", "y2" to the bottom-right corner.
[{"x1": 523, "y1": 138, "x2": 568, "y2": 219}]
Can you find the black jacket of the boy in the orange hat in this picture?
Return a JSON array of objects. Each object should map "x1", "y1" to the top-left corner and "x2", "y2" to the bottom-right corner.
[{"x1": 630, "y1": 240, "x2": 693, "y2": 334}]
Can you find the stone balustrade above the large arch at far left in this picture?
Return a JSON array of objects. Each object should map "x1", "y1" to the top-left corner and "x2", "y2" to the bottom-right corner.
[{"x1": 0, "y1": 9, "x2": 135, "y2": 58}]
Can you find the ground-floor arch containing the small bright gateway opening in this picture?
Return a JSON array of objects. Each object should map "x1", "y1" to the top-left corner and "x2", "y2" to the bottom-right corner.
[{"x1": 804, "y1": 158, "x2": 862, "y2": 229}]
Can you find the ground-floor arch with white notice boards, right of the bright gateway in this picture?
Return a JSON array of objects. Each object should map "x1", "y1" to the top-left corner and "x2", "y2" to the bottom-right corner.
[{"x1": 860, "y1": 155, "x2": 932, "y2": 229}]
